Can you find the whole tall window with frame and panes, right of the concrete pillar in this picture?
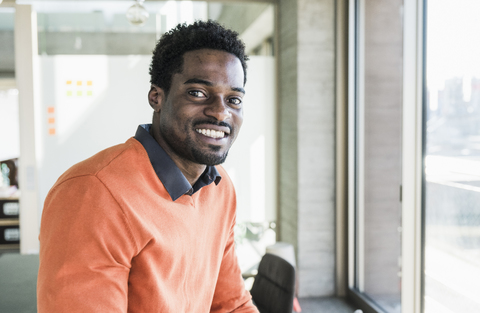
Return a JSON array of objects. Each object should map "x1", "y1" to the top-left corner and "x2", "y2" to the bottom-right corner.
[{"x1": 349, "y1": 0, "x2": 480, "y2": 313}]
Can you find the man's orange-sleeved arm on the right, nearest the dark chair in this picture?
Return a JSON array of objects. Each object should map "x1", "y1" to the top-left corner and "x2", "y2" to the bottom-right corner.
[{"x1": 210, "y1": 217, "x2": 258, "y2": 313}]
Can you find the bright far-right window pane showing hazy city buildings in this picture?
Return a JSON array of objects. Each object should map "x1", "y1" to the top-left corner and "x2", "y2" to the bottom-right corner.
[{"x1": 424, "y1": 0, "x2": 480, "y2": 313}]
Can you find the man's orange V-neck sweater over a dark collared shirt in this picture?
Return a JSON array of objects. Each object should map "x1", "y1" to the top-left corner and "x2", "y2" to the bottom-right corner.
[{"x1": 37, "y1": 138, "x2": 258, "y2": 313}]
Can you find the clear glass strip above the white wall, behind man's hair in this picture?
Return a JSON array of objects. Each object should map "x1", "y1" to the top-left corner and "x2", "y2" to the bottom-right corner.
[{"x1": 31, "y1": 0, "x2": 274, "y2": 56}]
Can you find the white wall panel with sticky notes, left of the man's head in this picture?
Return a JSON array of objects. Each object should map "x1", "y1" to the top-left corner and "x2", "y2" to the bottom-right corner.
[{"x1": 37, "y1": 55, "x2": 152, "y2": 208}]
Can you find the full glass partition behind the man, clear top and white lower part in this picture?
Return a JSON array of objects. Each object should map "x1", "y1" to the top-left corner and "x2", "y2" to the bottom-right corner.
[{"x1": 9, "y1": 0, "x2": 276, "y2": 262}]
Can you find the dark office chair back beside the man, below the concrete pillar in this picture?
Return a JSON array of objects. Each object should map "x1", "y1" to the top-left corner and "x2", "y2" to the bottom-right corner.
[{"x1": 250, "y1": 253, "x2": 295, "y2": 313}]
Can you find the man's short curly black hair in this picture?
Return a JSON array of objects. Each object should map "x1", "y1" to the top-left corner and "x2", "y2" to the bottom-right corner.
[{"x1": 150, "y1": 20, "x2": 248, "y2": 94}]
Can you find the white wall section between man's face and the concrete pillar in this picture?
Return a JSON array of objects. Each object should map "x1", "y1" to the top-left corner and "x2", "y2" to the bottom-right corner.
[{"x1": 223, "y1": 56, "x2": 277, "y2": 222}]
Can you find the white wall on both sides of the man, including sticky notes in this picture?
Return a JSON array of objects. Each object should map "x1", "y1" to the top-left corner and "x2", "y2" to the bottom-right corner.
[{"x1": 37, "y1": 55, "x2": 276, "y2": 222}]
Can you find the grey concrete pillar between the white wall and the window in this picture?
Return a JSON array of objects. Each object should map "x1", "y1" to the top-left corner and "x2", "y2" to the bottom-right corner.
[{"x1": 278, "y1": 0, "x2": 335, "y2": 296}]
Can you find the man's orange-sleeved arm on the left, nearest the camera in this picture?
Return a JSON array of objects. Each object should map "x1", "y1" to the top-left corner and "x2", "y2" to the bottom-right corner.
[{"x1": 37, "y1": 176, "x2": 137, "y2": 313}]
